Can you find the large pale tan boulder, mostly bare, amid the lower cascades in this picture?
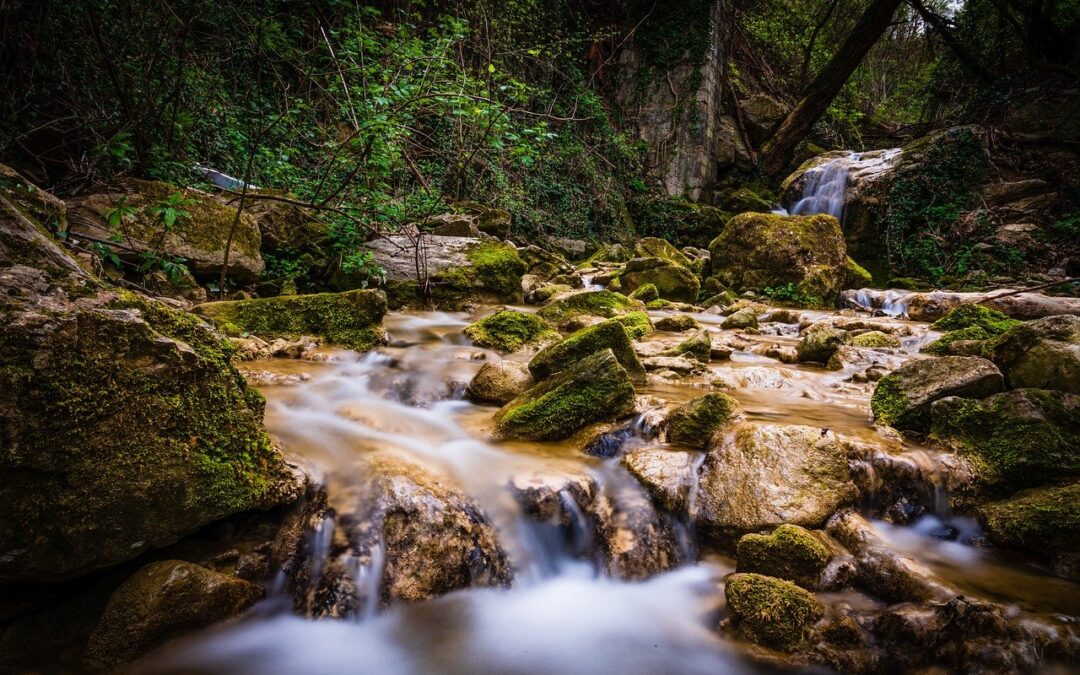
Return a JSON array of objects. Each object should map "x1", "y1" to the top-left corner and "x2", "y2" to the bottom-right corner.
[{"x1": 698, "y1": 423, "x2": 855, "y2": 539}]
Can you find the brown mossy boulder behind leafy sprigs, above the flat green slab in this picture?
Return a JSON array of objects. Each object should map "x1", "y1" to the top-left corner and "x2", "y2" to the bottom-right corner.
[{"x1": 68, "y1": 179, "x2": 264, "y2": 283}]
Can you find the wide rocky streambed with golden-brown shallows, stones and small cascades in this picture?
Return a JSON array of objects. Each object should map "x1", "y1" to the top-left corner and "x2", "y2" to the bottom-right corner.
[{"x1": 116, "y1": 302, "x2": 1080, "y2": 673}]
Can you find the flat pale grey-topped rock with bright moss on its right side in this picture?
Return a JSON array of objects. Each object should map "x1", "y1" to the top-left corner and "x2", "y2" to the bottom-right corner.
[{"x1": 365, "y1": 234, "x2": 525, "y2": 310}]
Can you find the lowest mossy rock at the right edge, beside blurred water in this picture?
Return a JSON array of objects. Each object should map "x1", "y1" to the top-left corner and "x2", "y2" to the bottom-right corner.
[{"x1": 977, "y1": 483, "x2": 1080, "y2": 578}]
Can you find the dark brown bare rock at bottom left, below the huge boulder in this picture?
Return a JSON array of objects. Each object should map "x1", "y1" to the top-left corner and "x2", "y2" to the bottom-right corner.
[{"x1": 84, "y1": 561, "x2": 265, "y2": 671}]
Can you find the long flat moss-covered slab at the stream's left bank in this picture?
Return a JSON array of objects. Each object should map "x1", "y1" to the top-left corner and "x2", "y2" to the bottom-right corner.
[{"x1": 194, "y1": 291, "x2": 387, "y2": 351}]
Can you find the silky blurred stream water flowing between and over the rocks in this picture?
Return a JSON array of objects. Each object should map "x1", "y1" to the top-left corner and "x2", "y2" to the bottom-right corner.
[{"x1": 140, "y1": 311, "x2": 1080, "y2": 674}]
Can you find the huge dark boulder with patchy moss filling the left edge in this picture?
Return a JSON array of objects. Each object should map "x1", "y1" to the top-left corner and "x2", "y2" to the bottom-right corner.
[{"x1": 0, "y1": 172, "x2": 298, "y2": 581}]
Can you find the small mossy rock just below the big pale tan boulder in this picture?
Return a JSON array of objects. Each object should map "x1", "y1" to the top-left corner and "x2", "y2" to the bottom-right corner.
[{"x1": 737, "y1": 525, "x2": 832, "y2": 591}]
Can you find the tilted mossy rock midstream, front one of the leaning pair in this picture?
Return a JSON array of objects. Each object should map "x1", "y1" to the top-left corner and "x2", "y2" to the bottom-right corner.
[{"x1": 495, "y1": 349, "x2": 634, "y2": 441}]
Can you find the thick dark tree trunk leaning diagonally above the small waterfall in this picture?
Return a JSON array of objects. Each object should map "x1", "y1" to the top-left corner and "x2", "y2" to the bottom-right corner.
[{"x1": 761, "y1": 0, "x2": 901, "y2": 176}]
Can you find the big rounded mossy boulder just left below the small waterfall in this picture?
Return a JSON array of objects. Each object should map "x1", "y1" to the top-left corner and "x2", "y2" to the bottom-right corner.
[{"x1": 708, "y1": 213, "x2": 848, "y2": 307}]
